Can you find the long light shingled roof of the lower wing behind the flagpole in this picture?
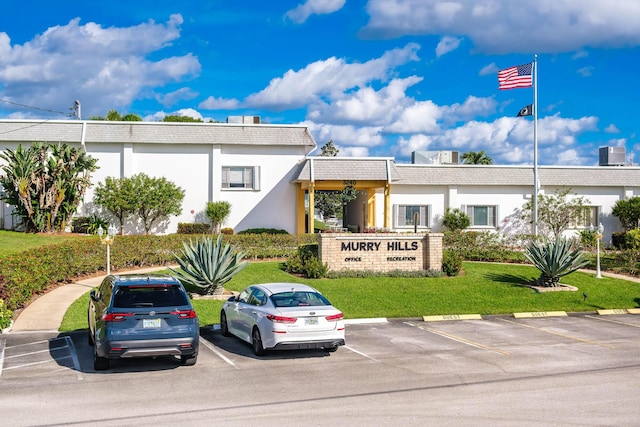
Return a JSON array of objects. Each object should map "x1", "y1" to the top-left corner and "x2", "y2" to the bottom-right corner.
[{"x1": 393, "y1": 164, "x2": 640, "y2": 187}]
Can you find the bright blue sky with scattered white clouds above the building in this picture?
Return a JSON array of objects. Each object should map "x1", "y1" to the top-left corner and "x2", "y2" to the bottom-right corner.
[{"x1": 0, "y1": 0, "x2": 640, "y2": 166}]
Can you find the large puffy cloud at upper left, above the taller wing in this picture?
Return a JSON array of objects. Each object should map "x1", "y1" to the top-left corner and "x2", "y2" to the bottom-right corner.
[{"x1": 0, "y1": 15, "x2": 201, "y2": 116}]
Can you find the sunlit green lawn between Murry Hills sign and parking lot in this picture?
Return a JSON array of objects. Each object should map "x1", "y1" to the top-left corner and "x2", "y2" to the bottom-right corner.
[{"x1": 61, "y1": 262, "x2": 640, "y2": 331}]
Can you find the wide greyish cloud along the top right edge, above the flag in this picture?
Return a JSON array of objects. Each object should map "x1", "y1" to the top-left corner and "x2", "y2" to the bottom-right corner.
[{"x1": 362, "y1": 0, "x2": 640, "y2": 54}]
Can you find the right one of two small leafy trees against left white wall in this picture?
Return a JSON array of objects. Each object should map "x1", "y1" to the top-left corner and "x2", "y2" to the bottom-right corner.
[{"x1": 131, "y1": 173, "x2": 184, "y2": 234}]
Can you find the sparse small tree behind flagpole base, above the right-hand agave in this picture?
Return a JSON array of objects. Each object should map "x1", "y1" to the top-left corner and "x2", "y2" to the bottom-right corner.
[{"x1": 522, "y1": 188, "x2": 589, "y2": 240}]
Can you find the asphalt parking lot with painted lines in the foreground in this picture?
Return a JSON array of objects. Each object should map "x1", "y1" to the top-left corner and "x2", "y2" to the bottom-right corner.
[{"x1": 0, "y1": 314, "x2": 640, "y2": 426}]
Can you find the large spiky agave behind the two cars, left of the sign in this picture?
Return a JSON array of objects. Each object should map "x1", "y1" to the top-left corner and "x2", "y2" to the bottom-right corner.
[{"x1": 170, "y1": 235, "x2": 247, "y2": 295}]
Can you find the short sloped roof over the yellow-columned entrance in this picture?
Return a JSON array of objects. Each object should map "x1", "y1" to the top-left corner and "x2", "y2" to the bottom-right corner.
[{"x1": 293, "y1": 156, "x2": 400, "y2": 182}]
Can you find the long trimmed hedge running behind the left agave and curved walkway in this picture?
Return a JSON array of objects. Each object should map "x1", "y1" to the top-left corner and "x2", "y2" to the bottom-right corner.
[{"x1": 0, "y1": 234, "x2": 317, "y2": 310}]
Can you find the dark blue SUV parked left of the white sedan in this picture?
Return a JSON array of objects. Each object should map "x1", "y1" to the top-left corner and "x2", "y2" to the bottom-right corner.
[{"x1": 88, "y1": 275, "x2": 200, "y2": 370}]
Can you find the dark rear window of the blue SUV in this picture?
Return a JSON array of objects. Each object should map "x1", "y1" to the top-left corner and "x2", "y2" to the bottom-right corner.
[{"x1": 113, "y1": 285, "x2": 188, "y2": 308}]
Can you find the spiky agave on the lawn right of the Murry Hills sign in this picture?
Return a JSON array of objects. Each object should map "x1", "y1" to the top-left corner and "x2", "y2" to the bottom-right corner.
[{"x1": 524, "y1": 238, "x2": 589, "y2": 287}]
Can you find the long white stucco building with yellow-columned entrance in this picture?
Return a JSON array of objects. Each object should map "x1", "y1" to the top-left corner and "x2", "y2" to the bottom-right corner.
[{"x1": 0, "y1": 120, "x2": 640, "y2": 240}]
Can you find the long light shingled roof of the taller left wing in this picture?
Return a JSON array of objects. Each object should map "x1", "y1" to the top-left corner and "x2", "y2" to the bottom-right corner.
[{"x1": 0, "y1": 120, "x2": 316, "y2": 147}]
